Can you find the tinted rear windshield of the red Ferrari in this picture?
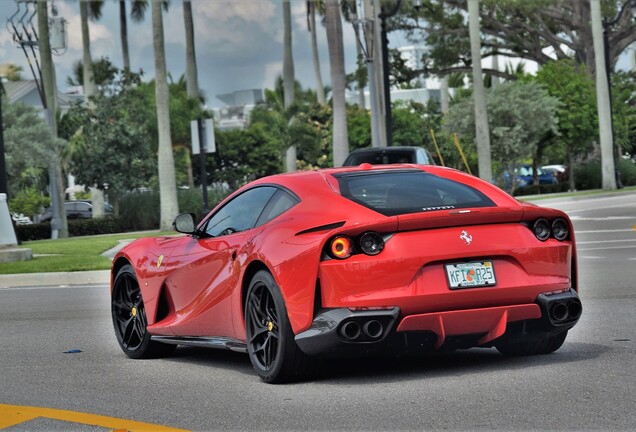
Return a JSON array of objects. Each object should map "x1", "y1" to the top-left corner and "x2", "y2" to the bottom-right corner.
[{"x1": 336, "y1": 170, "x2": 495, "y2": 216}]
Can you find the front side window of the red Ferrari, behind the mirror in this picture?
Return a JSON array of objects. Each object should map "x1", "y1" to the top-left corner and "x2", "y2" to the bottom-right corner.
[{"x1": 205, "y1": 186, "x2": 278, "y2": 237}]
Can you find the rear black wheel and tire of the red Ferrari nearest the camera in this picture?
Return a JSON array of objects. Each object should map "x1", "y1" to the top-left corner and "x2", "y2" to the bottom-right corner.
[{"x1": 245, "y1": 270, "x2": 315, "y2": 384}]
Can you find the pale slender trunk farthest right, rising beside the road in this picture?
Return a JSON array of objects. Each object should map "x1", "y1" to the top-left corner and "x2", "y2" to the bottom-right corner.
[{"x1": 590, "y1": 0, "x2": 616, "y2": 190}]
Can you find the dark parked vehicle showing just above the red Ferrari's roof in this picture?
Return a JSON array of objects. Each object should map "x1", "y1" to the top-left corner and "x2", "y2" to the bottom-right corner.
[{"x1": 343, "y1": 146, "x2": 435, "y2": 166}]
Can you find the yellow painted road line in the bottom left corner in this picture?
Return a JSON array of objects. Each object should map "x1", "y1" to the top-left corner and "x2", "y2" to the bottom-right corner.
[{"x1": 0, "y1": 404, "x2": 186, "y2": 432}]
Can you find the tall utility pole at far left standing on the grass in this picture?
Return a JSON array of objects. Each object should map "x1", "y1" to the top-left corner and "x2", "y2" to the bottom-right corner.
[{"x1": 36, "y1": 2, "x2": 68, "y2": 238}]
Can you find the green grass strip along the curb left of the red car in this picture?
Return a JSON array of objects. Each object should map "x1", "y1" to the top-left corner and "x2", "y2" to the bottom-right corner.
[{"x1": 0, "y1": 231, "x2": 175, "y2": 274}]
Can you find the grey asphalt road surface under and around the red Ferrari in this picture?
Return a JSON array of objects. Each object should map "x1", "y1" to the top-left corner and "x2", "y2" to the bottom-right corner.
[{"x1": 0, "y1": 193, "x2": 636, "y2": 431}]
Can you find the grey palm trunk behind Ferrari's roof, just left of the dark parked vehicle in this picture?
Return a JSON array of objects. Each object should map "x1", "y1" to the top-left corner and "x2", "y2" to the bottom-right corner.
[{"x1": 325, "y1": 0, "x2": 349, "y2": 166}]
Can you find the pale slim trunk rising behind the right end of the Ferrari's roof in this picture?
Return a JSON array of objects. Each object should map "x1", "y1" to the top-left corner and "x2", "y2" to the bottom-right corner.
[{"x1": 468, "y1": 0, "x2": 492, "y2": 182}]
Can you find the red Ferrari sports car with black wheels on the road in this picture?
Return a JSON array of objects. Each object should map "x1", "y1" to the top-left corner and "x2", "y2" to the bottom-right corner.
[{"x1": 111, "y1": 164, "x2": 582, "y2": 382}]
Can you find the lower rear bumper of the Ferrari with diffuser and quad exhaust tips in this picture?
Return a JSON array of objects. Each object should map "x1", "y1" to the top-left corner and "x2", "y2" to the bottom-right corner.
[{"x1": 296, "y1": 289, "x2": 582, "y2": 356}]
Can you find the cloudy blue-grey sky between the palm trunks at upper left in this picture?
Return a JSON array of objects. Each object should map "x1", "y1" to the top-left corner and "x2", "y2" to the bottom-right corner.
[{"x1": 0, "y1": 0, "x2": 366, "y2": 108}]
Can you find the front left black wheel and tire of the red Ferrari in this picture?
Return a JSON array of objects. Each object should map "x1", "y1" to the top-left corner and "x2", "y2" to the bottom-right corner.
[{"x1": 111, "y1": 264, "x2": 176, "y2": 359}]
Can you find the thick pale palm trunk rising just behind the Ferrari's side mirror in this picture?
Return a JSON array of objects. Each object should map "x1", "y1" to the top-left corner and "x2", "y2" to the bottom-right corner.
[{"x1": 152, "y1": 0, "x2": 179, "y2": 230}]
